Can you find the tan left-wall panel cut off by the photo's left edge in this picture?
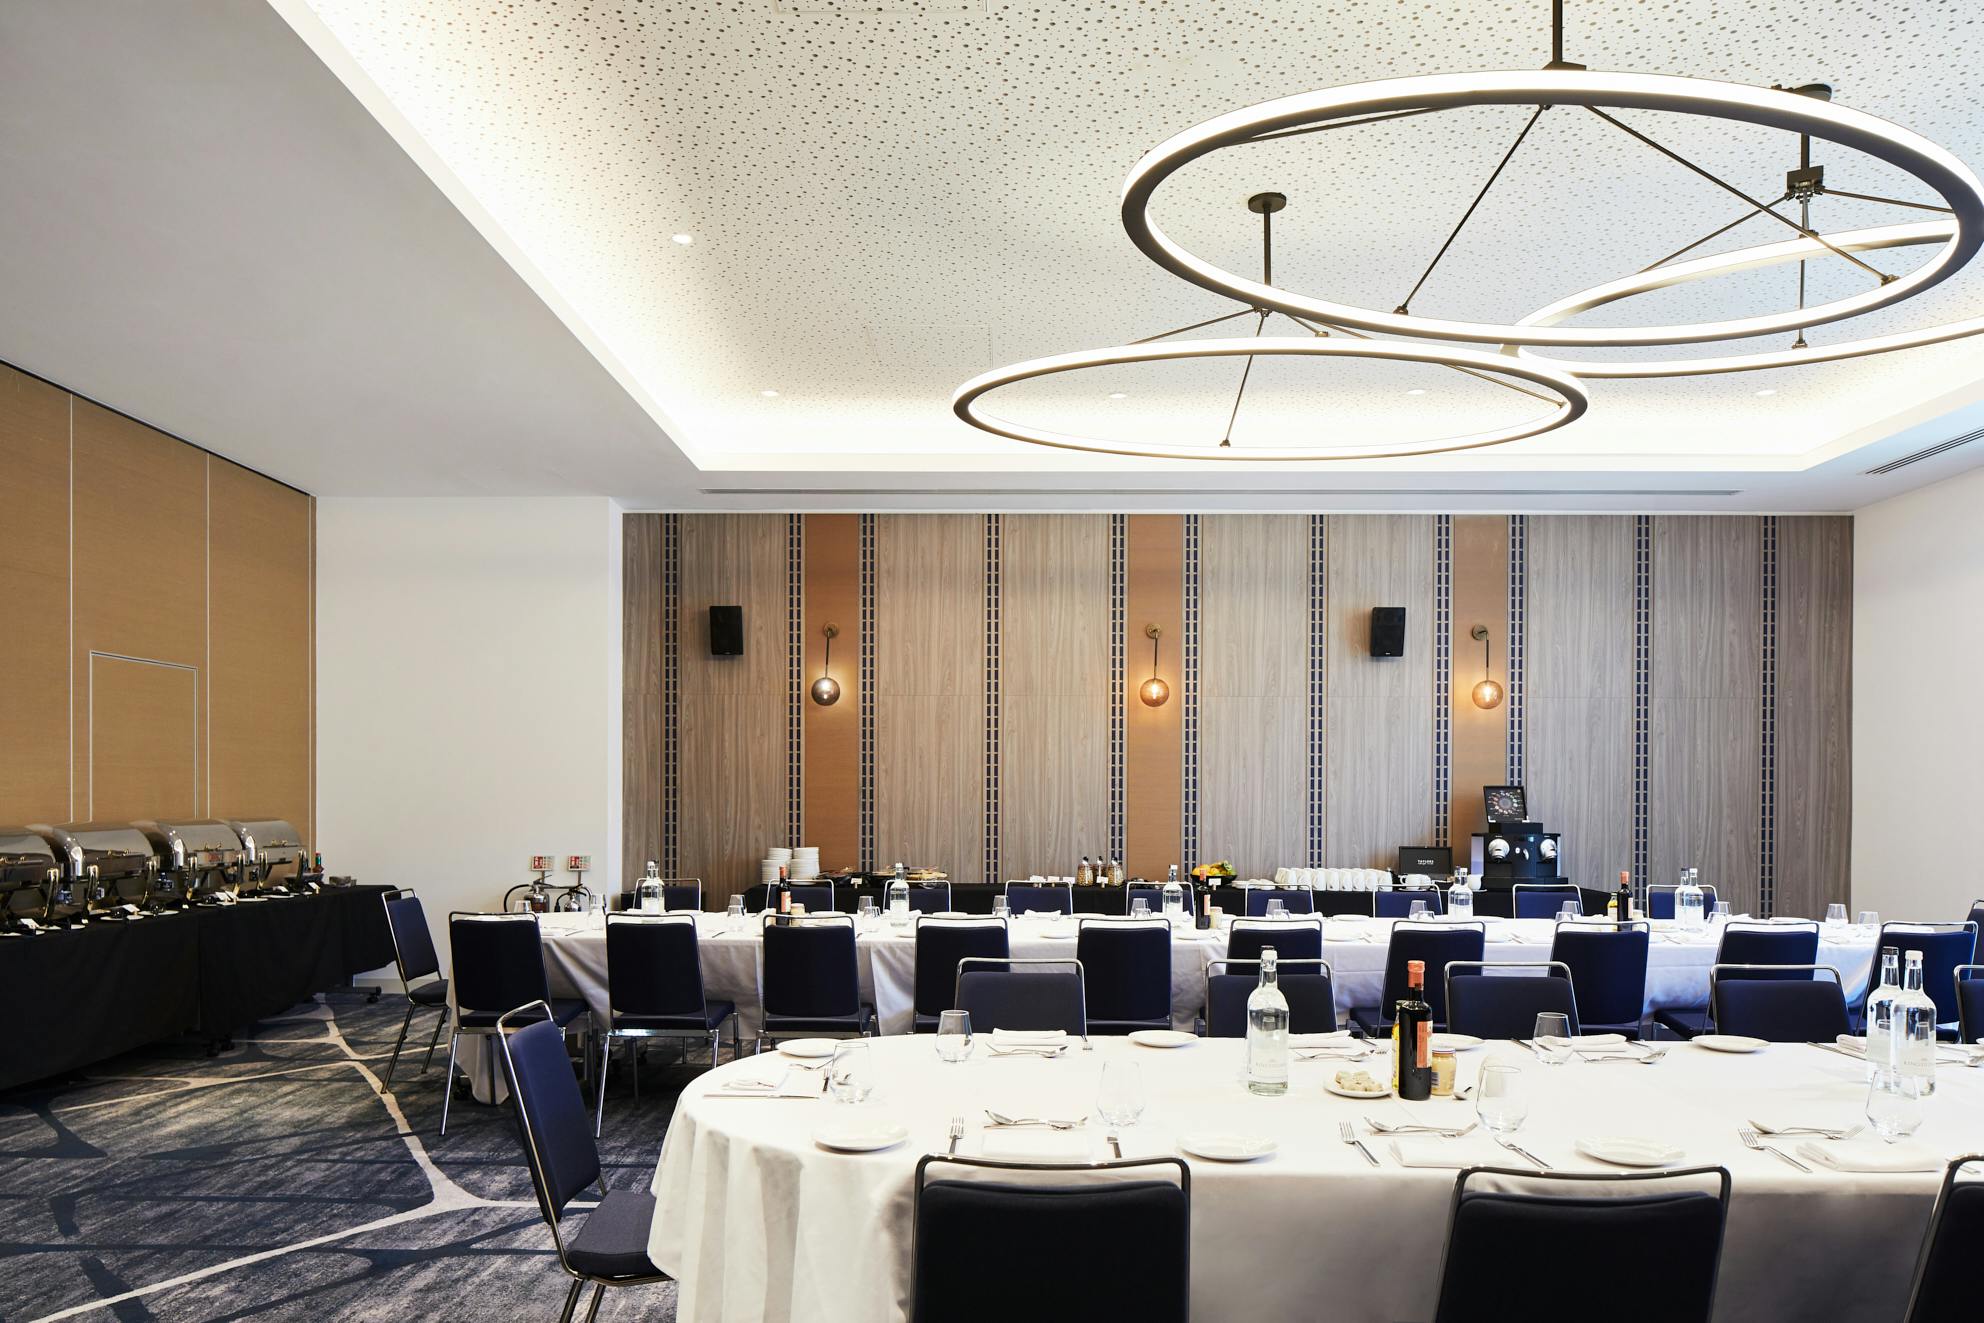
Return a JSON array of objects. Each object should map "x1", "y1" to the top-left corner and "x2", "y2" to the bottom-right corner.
[{"x1": 0, "y1": 367, "x2": 73, "y2": 823}]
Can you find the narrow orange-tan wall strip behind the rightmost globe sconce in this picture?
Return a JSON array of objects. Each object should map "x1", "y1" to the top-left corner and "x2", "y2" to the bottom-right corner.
[{"x1": 1452, "y1": 514, "x2": 1507, "y2": 848}]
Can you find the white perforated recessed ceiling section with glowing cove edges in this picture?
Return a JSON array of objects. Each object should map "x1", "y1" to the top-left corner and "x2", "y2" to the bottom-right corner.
[{"x1": 297, "y1": 0, "x2": 1984, "y2": 466}]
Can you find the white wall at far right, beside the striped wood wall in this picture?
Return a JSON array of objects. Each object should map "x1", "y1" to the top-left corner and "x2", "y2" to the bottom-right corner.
[{"x1": 1853, "y1": 468, "x2": 1984, "y2": 920}]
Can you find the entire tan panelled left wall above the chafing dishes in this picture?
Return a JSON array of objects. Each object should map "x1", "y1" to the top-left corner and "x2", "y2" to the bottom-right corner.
[{"x1": 0, "y1": 357, "x2": 315, "y2": 843}]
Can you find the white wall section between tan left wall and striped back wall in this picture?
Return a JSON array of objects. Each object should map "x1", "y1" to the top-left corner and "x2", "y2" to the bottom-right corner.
[{"x1": 317, "y1": 498, "x2": 621, "y2": 966}]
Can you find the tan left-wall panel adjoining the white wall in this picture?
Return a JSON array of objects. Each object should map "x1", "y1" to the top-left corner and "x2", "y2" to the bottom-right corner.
[{"x1": 202, "y1": 458, "x2": 315, "y2": 841}]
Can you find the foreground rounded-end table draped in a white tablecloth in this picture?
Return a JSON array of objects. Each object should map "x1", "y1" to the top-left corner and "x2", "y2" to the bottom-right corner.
[{"x1": 649, "y1": 1035, "x2": 1984, "y2": 1323}]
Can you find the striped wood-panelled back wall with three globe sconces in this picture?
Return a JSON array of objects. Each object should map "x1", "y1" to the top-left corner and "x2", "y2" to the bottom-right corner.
[{"x1": 625, "y1": 514, "x2": 1851, "y2": 910}]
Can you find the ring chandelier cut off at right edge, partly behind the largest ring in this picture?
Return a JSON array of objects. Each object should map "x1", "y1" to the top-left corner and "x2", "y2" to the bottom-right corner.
[{"x1": 1510, "y1": 220, "x2": 1984, "y2": 372}]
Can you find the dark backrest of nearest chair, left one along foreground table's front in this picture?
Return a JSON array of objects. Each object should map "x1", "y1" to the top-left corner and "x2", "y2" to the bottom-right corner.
[{"x1": 909, "y1": 1154, "x2": 1192, "y2": 1323}]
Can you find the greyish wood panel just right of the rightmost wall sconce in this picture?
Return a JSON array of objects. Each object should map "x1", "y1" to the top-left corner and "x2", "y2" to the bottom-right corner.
[{"x1": 1523, "y1": 516, "x2": 1634, "y2": 887}]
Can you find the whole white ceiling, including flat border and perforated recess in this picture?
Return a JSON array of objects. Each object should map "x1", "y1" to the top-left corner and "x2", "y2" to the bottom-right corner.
[{"x1": 0, "y1": 0, "x2": 1984, "y2": 510}]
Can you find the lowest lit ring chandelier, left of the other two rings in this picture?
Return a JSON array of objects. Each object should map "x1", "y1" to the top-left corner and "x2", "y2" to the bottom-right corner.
[{"x1": 950, "y1": 337, "x2": 1591, "y2": 462}]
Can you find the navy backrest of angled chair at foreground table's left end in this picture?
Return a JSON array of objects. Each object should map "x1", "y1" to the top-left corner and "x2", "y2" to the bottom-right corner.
[{"x1": 496, "y1": 1002, "x2": 599, "y2": 1229}]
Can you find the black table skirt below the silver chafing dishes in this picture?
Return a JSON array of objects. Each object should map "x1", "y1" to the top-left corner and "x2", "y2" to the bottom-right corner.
[{"x1": 0, "y1": 887, "x2": 393, "y2": 1089}]
